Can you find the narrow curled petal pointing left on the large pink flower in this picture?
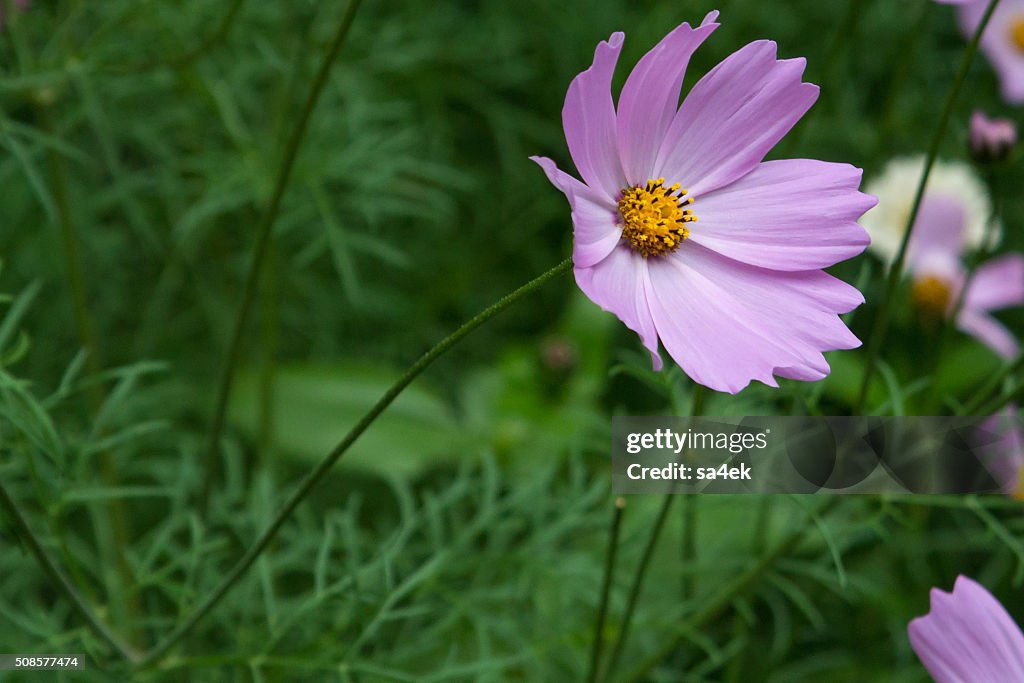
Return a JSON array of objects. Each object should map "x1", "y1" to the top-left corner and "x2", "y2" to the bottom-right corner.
[{"x1": 530, "y1": 157, "x2": 622, "y2": 268}]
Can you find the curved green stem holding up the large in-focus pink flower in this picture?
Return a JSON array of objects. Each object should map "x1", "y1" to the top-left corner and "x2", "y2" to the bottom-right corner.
[{"x1": 132, "y1": 259, "x2": 572, "y2": 667}]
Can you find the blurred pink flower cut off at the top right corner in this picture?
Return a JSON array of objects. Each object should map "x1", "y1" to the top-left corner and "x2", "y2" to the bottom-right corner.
[{"x1": 947, "y1": 0, "x2": 1024, "y2": 104}]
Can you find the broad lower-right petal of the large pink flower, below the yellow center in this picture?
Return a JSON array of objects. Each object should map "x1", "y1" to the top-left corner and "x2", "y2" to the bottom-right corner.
[{"x1": 647, "y1": 242, "x2": 863, "y2": 393}]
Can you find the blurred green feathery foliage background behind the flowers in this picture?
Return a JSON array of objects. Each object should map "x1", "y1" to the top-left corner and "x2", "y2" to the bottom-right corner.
[{"x1": 0, "y1": 0, "x2": 1024, "y2": 681}]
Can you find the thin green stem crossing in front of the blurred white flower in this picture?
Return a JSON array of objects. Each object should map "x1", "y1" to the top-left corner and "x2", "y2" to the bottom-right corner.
[{"x1": 853, "y1": 0, "x2": 999, "y2": 415}]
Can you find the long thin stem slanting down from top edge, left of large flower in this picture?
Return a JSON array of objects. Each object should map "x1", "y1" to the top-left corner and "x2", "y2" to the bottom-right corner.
[{"x1": 200, "y1": 0, "x2": 361, "y2": 509}]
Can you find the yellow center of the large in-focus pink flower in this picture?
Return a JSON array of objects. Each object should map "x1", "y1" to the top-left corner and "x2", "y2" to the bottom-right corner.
[{"x1": 618, "y1": 178, "x2": 697, "y2": 258}]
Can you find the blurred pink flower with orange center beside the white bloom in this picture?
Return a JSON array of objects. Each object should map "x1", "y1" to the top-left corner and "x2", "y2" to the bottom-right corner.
[{"x1": 907, "y1": 195, "x2": 1024, "y2": 358}]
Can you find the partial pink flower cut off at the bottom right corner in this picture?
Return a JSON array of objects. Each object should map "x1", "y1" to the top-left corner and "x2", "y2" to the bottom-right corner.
[{"x1": 907, "y1": 577, "x2": 1024, "y2": 683}]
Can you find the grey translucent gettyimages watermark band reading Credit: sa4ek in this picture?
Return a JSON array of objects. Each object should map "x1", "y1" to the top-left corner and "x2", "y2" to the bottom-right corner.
[{"x1": 611, "y1": 417, "x2": 1024, "y2": 495}]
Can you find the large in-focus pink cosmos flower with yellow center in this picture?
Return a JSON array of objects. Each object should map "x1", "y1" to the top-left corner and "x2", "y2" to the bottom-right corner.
[{"x1": 531, "y1": 12, "x2": 874, "y2": 393}]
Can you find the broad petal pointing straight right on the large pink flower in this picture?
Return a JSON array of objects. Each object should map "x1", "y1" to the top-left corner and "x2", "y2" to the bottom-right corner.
[{"x1": 690, "y1": 159, "x2": 877, "y2": 270}]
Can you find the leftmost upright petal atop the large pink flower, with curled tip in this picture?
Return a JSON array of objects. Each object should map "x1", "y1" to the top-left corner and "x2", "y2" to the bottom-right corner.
[{"x1": 562, "y1": 33, "x2": 626, "y2": 199}]
